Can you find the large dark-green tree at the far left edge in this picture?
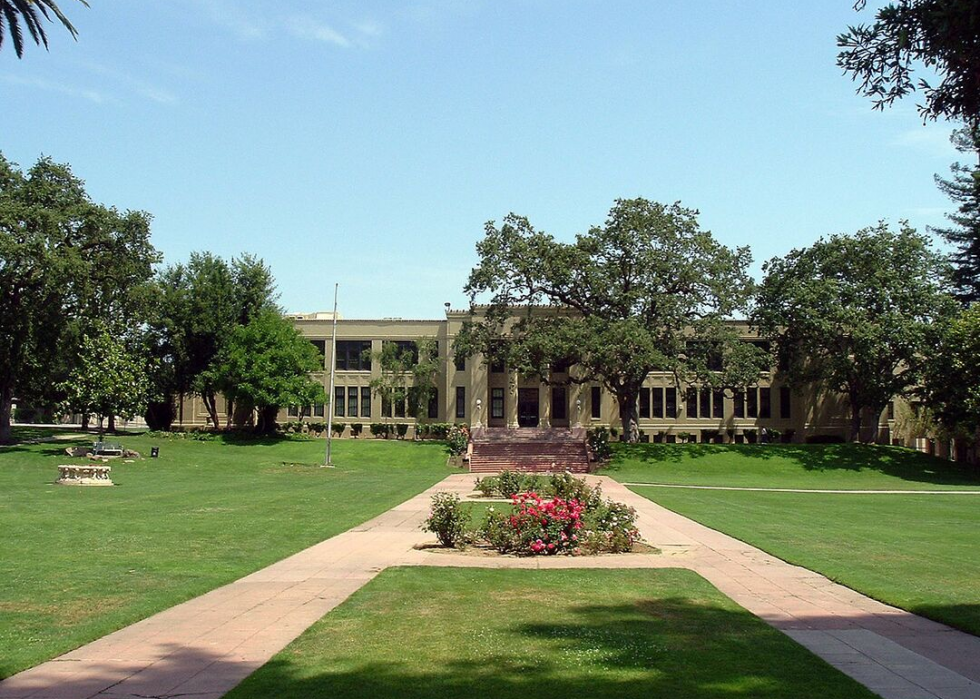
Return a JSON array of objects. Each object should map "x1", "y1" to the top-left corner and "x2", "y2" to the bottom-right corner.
[{"x1": 0, "y1": 155, "x2": 158, "y2": 442}]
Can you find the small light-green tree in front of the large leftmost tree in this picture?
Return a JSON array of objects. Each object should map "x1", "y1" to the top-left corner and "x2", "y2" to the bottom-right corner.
[{"x1": 61, "y1": 323, "x2": 150, "y2": 436}]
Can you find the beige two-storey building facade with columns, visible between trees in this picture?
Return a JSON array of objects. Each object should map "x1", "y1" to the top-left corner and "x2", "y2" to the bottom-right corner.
[{"x1": 178, "y1": 309, "x2": 901, "y2": 442}]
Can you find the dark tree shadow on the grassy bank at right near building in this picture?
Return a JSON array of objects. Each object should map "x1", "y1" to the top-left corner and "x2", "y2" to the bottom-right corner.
[{"x1": 603, "y1": 444, "x2": 980, "y2": 485}]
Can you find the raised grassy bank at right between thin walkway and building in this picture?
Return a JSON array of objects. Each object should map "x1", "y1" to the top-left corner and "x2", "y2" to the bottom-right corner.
[{"x1": 600, "y1": 444, "x2": 980, "y2": 490}]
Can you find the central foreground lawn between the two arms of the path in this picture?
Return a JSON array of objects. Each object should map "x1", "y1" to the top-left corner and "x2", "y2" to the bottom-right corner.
[{"x1": 226, "y1": 568, "x2": 875, "y2": 699}]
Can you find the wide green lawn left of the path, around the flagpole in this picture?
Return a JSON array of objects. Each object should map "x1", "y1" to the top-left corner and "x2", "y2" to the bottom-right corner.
[{"x1": 0, "y1": 437, "x2": 452, "y2": 677}]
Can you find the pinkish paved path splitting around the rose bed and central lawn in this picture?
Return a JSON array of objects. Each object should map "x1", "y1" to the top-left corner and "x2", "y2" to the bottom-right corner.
[{"x1": 0, "y1": 474, "x2": 980, "y2": 699}]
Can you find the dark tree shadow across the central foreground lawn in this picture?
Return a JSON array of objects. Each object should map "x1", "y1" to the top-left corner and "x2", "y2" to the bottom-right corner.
[{"x1": 227, "y1": 598, "x2": 875, "y2": 699}]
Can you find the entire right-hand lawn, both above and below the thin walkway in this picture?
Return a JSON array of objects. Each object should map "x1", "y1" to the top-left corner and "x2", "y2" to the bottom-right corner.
[{"x1": 604, "y1": 445, "x2": 980, "y2": 635}]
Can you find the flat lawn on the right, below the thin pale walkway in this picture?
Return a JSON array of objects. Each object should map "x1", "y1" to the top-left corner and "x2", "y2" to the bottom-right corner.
[{"x1": 634, "y1": 487, "x2": 980, "y2": 636}]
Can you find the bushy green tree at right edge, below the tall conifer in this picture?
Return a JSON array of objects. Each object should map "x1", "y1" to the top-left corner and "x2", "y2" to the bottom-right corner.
[{"x1": 922, "y1": 305, "x2": 980, "y2": 454}]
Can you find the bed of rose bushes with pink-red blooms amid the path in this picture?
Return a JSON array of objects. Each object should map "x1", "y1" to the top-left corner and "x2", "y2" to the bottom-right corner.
[{"x1": 423, "y1": 474, "x2": 640, "y2": 556}]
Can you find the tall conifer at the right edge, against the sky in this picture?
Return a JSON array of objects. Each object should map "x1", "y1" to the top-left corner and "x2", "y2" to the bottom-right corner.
[{"x1": 932, "y1": 129, "x2": 980, "y2": 304}]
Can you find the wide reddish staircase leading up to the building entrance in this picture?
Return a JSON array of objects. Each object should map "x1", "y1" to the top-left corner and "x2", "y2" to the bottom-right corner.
[{"x1": 469, "y1": 427, "x2": 590, "y2": 473}]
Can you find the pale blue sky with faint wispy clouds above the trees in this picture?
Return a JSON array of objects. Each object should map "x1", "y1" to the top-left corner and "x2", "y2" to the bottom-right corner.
[{"x1": 0, "y1": 0, "x2": 958, "y2": 318}]
